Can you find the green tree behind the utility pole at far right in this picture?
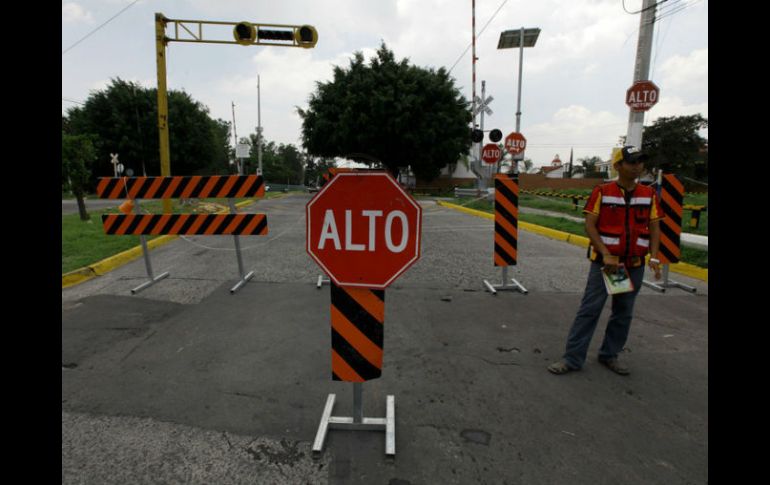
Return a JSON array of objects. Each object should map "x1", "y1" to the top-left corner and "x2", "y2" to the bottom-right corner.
[{"x1": 642, "y1": 114, "x2": 708, "y2": 180}]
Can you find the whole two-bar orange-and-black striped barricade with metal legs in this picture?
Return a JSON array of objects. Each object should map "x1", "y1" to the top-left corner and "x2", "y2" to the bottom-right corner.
[{"x1": 96, "y1": 175, "x2": 268, "y2": 294}]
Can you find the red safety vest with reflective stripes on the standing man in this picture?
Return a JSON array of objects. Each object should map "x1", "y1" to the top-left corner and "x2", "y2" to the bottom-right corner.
[{"x1": 591, "y1": 182, "x2": 656, "y2": 261}]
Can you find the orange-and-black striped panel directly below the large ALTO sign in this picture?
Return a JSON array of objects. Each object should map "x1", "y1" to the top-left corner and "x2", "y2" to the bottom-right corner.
[{"x1": 331, "y1": 281, "x2": 385, "y2": 382}]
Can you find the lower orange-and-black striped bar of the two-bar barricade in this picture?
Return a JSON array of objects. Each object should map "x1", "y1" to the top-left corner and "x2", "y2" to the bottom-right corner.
[{"x1": 102, "y1": 214, "x2": 268, "y2": 236}]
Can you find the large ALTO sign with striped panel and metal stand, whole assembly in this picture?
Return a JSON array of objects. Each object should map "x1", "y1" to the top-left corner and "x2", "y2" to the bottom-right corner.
[{"x1": 305, "y1": 171, "x2": 422, "y2": 458}]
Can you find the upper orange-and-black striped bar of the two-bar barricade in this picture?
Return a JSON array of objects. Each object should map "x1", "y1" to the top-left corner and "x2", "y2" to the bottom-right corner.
[{"x1": 96, "y1": 175, "x2": 265, "y2": 199}]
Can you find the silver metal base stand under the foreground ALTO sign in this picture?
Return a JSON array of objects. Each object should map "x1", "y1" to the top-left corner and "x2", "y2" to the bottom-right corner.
[{"x1": 313, "y1": 382, "x2": 396, "y2": 458}]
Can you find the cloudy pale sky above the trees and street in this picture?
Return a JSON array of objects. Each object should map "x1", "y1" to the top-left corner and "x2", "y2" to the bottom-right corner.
[{"x1": 62, "y1": 0, "x2": 708, "y2": 167}]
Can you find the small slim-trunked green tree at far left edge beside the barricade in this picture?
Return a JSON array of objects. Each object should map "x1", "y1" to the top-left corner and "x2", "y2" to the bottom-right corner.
[{"x1": 61, "y1": 131, "x2": 96, "y2": 221}]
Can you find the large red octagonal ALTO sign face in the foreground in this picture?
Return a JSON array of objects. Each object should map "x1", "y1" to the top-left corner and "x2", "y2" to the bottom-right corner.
[{"x1": 305, "y1": 172, "x2": 422, "y2": 289}]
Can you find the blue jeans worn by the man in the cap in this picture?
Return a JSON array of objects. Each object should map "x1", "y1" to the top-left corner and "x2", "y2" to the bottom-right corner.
[{"x1": 564, "y1": 262, "x2": 644, "y2": 369}]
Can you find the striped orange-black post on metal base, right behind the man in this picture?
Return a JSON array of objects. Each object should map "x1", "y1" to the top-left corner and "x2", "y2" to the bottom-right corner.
[{"x1": 642, "y1": 171, "x2": 697, "y2": 293}]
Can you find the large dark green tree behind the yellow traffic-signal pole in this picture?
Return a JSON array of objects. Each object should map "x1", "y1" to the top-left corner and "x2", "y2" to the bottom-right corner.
[{"x1": 62, "y1": 78, "x2": 230, "y2": 184}]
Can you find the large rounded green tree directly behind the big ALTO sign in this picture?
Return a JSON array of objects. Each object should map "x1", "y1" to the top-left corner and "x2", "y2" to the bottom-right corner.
[{"x1": 298, "y1": 43, "x2": 471, "y2": 181}]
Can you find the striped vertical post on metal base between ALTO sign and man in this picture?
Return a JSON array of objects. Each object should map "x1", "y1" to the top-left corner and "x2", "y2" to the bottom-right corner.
[{"x1": 484, "y1": 173, "x2": 528, "y2": 295}]
